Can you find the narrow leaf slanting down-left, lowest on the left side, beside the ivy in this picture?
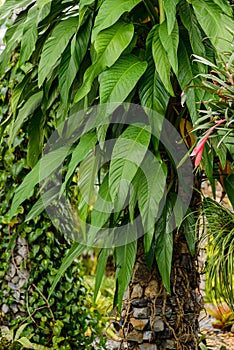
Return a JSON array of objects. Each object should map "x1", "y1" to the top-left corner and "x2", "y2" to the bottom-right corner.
[{"x1": 48, "y1": 242, "x2": 87, "y2": 299}]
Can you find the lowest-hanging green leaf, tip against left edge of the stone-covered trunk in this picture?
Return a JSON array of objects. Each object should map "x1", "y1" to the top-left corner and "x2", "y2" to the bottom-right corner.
[{"x1": 115, "y1": 228, "x2": 137, "y2": 309}]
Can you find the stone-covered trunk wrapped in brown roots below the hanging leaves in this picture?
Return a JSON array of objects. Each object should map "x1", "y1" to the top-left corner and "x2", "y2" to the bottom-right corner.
[{"x1": 120, "y1": 194, "x2": 202, "y2": 350}]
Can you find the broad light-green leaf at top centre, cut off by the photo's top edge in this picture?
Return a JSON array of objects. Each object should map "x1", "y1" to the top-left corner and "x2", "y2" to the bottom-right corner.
[{"x1": 92, "y1": 0, "x2": 141, "y2": 42}]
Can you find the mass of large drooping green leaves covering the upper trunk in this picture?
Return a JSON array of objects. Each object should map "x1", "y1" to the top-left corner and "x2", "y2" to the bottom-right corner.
[{"x1": 0, "y1": 0, "x2": 233, "y2": 316}]
